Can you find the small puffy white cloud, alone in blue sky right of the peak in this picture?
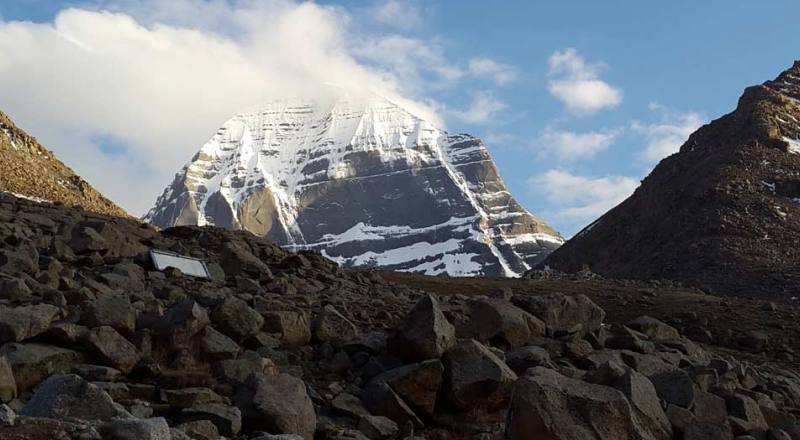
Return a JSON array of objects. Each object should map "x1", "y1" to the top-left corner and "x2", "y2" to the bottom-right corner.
[{"x1": 547, "y1": 48, "x2": 622, "y2": 114}]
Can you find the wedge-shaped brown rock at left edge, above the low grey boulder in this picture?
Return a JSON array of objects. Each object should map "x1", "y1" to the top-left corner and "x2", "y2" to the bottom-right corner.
[{"x1": 0, "y1": 343, "x2": 84, "y2": 393}]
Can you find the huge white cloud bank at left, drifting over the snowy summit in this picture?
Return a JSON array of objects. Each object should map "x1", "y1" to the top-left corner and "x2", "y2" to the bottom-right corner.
[{"x1": 0, "y1": 0, "x2": 466, "y2": 214}]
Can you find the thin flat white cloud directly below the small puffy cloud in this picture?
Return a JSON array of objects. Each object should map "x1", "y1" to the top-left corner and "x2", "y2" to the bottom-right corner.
[{"x1": 541, "y1": 128, "x2": 619, "y2": 160}]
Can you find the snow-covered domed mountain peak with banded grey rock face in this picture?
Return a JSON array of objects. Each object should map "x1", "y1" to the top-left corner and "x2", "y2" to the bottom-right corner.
[{"x1": 145, "y1": 91, "x2": 563, "y2": 276}]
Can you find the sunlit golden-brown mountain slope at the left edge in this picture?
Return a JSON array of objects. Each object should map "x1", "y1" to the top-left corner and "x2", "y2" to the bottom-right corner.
[{"x1": 0, "y1": 112, "x2": 128, "y2": 217}]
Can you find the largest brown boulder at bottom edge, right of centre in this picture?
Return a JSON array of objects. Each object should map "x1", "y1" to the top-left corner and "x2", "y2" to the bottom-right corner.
[{"x1": 506, "y1": 367, "x2": 672, "y2": 440}]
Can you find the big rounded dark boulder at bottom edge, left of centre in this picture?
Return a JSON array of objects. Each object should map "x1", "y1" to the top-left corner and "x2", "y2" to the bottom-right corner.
[{"x1": 233, "y1": 374, "x2": 317, "y2": 440}]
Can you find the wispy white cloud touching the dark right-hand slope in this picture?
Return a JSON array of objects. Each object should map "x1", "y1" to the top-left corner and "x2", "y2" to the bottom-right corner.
[{"x1": 631, "y1": 103, "x2": 705, "y2": 163}]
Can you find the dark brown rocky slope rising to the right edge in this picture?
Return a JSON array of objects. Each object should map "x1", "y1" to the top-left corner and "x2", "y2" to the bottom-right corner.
[{"x1": 543, "y1": 62, "x2": 800, "y2": 295}]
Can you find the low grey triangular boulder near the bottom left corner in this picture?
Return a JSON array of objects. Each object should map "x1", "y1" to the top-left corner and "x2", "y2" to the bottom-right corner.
[{"x1": 20, "y1": 374, "x2": 130, "y2": 420}]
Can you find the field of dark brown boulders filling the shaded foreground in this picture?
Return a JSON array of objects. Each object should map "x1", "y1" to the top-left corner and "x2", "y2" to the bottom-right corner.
[{"x1": 0, "y1": 195, "x2": 800, "y2": 440}]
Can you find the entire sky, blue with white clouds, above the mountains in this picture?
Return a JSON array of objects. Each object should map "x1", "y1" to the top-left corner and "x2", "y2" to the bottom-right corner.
[{"x1": 0, "y1": 0, "x2": 800, "y2": 236}]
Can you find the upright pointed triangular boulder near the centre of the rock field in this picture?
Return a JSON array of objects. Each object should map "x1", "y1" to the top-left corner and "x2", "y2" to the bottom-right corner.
[{"x1": 388, "y1": 295, "x2": 455, "y2": 361}]
